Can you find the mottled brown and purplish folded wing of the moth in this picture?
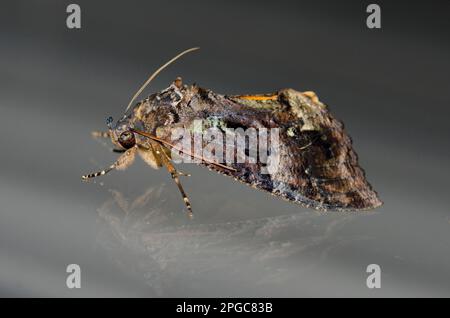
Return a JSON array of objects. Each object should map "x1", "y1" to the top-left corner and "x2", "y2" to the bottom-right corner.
[{"x1": 160, "y1": 85, "x2": 382, "y2": 211}]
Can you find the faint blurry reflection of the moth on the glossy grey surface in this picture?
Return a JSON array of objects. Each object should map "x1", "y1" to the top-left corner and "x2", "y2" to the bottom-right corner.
[{"x1": 97, "y1": 185, "x2": 370, "y2": 296}]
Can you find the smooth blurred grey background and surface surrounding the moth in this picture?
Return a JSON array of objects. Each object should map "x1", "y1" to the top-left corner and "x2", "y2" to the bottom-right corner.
[{"x1": 0, "y1": 1, "x2": 450, "y2": 297}]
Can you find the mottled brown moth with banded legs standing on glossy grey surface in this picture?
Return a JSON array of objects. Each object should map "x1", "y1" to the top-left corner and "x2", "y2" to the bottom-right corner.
[{"x1": 82, "y1": 48, "x2": 382, "y2": 216}]
